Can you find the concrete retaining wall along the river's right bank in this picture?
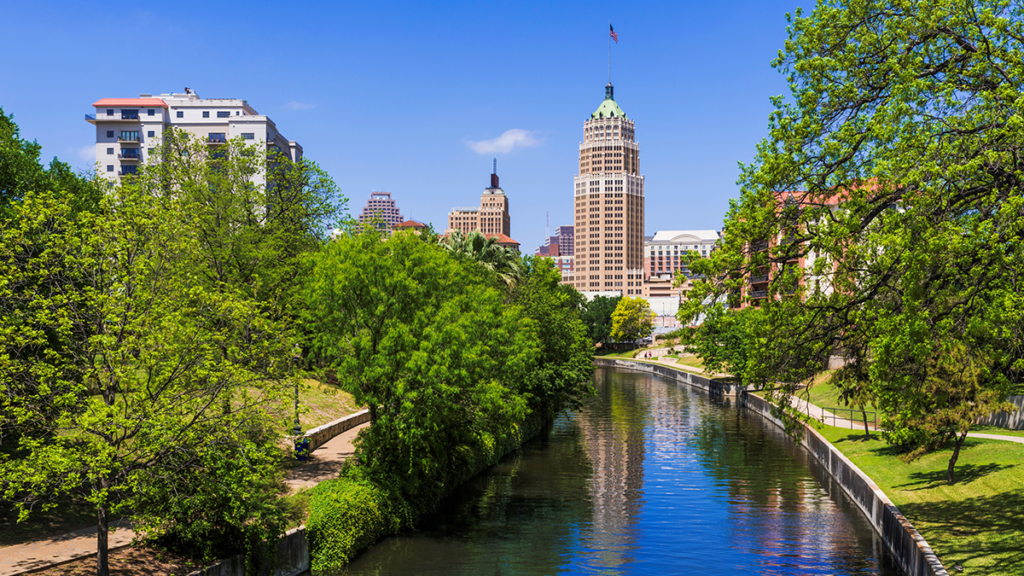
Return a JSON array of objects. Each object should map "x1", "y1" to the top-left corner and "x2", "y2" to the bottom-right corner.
[{"x1": 594, "y1": 358, "x2": 949, "y2": 576}]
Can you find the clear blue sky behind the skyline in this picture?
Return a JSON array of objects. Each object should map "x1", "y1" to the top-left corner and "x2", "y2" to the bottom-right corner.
[{"x1": 0, "y1": 0, "x2": 798, "y2": 252}]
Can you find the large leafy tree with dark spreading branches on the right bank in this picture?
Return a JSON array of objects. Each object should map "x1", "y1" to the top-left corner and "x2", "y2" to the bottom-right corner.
[{"x1": 675, "y1": 0, "x2": 1024, "y2": 482}]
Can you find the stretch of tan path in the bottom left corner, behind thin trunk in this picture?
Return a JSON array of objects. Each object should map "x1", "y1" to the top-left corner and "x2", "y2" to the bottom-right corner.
[{"x1": 0, "y1": 520, "x2": 135, "y2": 576}]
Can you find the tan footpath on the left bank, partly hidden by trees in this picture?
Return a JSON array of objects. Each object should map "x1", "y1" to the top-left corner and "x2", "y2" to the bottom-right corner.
[{"x1": 0, "y1": 423, "x2": 370, "y2": 576}]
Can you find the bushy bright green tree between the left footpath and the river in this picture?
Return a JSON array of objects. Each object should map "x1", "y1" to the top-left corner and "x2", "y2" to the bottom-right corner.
[{"x1": 304, "y1": 227, "x2": 540, "y2": 509}]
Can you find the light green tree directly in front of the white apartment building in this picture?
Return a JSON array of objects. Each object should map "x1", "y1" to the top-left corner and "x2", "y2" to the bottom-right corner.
[{"x1": 144, "y1": 129, "x2": 347, "y2": 317}]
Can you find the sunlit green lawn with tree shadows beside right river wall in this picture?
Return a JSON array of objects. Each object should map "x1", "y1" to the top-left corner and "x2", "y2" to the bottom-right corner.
[{"x1": 818, "y1": 426, "x2": 1024, "y2": 576}]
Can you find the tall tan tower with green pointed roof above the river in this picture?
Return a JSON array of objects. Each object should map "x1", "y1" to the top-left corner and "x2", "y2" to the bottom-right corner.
[{"x1": 572, "y1": 82, "x2": 644, "y2": 296}]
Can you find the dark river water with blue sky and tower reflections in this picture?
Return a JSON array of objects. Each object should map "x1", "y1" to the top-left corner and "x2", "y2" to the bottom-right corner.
[{"x1": 345, "y1": 369, "x2": 899, "y2": 576}]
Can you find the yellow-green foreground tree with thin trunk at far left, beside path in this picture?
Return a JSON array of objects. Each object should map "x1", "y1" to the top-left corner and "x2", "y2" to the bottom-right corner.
[{"x1": 0, "y1": 187, "x2": 288, "y2": 576}]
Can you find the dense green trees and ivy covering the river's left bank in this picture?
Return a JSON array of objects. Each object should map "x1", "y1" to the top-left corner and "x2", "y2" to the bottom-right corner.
[{"x1": 302, "y1": 228, "x2": 593, "y2": 573}]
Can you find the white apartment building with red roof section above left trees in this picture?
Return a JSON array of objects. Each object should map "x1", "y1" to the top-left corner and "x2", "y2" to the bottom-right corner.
[{"x1": 85, "y1": 88, "x2": 302, "y2": 178}]
